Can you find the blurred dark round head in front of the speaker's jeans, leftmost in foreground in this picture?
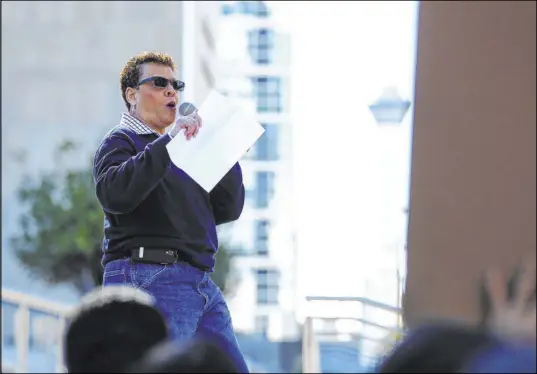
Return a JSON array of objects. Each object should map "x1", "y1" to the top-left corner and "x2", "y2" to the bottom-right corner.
[{"x1": 65, "y1": 286, "x2": 168, "y2": 373}]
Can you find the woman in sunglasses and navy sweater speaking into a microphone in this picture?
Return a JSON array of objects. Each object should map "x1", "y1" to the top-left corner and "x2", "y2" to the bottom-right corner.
[{"x1": 94, "y1": 53, "x2": 248, "y2": 372}]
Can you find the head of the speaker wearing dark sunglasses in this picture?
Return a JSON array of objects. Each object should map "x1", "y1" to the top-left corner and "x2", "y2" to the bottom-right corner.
[{"x1": 120, "y1": 52, "x2": 184, "y2": 134}]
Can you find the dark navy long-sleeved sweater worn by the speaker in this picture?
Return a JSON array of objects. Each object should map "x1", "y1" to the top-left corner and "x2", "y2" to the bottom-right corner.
[{"x1": 93, "y1": 126, "x2": 244, "y2": 271}]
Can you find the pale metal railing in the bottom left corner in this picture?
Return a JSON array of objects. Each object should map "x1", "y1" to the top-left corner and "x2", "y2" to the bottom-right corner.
[{"x1": 0, "y1": 288, "x2": 72, "y2": 373}]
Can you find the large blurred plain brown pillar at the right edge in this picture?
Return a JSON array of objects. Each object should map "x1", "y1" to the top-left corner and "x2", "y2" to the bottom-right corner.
[{"x1": 404, "y1": 1, "x2": 536, "y2": 327}]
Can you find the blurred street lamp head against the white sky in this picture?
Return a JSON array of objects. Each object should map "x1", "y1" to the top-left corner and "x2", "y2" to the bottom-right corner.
[{"x1": 369, "y1": 87, "x2": 410, "y2": 125}]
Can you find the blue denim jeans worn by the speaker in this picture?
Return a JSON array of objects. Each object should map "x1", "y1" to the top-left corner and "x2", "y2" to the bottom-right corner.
[{"x1": 103, "y1": 258, "x2": 249, "y2": 373}]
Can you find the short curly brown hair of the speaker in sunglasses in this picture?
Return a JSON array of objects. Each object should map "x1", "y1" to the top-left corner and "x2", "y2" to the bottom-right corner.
[{"x1": 119, "y1": 52, "x2": 175, "y2": 110}]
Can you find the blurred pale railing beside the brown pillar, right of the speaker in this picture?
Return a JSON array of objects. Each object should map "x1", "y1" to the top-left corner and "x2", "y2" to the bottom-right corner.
[{"x1": 302, "y1": 296, "x2": 403, "y2": 373}]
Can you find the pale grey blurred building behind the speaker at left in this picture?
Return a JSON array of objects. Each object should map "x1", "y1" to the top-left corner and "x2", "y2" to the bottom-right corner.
[{"x1": 2, "y1": 1, "x2": 220, "y2": 301}]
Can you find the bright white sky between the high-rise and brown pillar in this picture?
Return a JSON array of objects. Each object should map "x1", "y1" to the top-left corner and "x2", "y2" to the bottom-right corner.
[{"x1": 269, "y1": 1, "x2": 417, "y2": 318}]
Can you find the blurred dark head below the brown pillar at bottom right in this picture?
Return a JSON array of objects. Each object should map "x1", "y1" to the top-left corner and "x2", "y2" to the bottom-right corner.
[{"x1": 377, "y1": 323, "x2": 498, "y2": 373}]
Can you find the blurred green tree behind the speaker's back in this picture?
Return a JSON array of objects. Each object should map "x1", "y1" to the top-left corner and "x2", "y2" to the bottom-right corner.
[{"x1": 11, "y1": 141, "x2": 236, "y2": 294}]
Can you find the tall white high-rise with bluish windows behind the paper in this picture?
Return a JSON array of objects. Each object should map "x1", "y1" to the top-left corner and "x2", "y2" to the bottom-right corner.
[{"x1": 216, "y1": 1, "x2": 298, "y2": 340}]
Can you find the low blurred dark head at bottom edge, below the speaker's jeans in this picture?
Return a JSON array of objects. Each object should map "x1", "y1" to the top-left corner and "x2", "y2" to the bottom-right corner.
[{"x1": 128, "y1": 336, "x2": 239, "y2": 373}]
